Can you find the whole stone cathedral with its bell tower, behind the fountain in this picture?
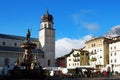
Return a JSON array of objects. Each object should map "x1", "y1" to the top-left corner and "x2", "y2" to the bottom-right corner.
[{"x1": 0, "y1": 11, "x2": 55, "y2": 67}]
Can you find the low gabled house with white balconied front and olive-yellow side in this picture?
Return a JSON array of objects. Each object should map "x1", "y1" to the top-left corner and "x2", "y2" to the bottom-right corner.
[{"x1": 65, "y1": 49, "x2": 89, "y2": 69}]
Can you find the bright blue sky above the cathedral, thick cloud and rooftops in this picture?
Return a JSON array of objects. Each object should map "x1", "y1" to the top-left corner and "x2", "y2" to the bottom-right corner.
[{"x1": 0, "y1": 0, "x2": 120, "y2": 57}]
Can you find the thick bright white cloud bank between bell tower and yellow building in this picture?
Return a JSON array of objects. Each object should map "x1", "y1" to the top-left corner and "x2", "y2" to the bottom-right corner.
[{"x1": 56, "y1": 35, "x2": 92, "y2": 57}]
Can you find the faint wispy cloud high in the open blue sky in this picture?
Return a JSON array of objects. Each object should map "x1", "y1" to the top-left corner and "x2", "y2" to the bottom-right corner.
[{"x1": 72, "y1": 9, "x2": 100, "y2": 31}]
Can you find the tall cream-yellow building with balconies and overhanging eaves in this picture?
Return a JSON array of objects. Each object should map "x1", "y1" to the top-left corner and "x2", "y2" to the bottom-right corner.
[{"x1": 85, "y1": 37, "x2": 111, "y2": 67}]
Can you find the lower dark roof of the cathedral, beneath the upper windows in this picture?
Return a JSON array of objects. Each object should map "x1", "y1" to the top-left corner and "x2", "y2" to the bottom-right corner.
[{"x1": 0, "y1": 46, "x2": 44, "y2": 53}]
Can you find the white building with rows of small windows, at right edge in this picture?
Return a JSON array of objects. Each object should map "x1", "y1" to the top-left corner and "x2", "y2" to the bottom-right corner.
[{"x1": 109, "y1": 36, "x2": 120, "y2": 73}]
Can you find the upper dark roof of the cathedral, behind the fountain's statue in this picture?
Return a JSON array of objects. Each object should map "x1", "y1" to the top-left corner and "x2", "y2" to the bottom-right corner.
[{"x1": 0, "y1": 34, "x2": 39, "y2": 42}]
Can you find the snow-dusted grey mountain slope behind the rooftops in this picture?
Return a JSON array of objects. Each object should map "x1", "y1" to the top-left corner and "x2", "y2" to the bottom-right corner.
[{"x1": 105, "y1": 25, "x2": 120, "y2": 37}]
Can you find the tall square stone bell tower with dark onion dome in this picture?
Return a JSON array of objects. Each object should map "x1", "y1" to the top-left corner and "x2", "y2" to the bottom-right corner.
[{"x1": 39, "y1": 11, "x2": 55, "y2": 67}]
